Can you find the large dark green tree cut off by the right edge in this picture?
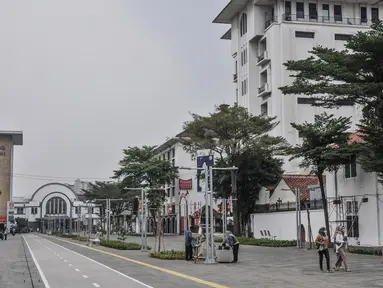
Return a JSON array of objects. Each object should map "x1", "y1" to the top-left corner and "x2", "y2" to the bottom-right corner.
[{"x1": 280, "y1": 22, "x2": 383, "y2": 181}]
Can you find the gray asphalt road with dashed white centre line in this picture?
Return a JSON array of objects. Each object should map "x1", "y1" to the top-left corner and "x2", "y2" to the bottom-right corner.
[{"x1": 24, "y1": 234, "x2": 152, "y2": 288}]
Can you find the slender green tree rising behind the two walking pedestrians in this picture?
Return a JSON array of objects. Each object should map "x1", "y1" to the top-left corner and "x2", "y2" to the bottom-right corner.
[{"x1": 288, "y1": 113, "x2": 360, "y2": 238}]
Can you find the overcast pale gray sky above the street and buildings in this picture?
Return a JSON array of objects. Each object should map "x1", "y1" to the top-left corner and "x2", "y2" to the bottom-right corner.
[{"x1": 0, "y1": 0, "x2": 234, "y2": 196}]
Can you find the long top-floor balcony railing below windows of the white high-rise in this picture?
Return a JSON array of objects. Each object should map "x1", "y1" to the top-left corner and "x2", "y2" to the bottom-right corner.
[{"x1": 282, "y1": 14, "x2": 376, "y2": 26}]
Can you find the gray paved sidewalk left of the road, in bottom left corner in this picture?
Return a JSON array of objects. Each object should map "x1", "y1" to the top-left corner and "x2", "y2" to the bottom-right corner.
[{"x1": 0, "y1": 234, "x2": 44, "y2": 288}]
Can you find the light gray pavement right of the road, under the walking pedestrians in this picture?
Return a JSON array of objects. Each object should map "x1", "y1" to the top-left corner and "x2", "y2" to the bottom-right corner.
[{"x1": 43, "y1": 236, "x2": 383, "y2": 288}]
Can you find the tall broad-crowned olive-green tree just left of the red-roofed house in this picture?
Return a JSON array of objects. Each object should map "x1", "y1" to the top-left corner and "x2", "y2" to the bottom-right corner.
[{"x1": 181, "y1": 105, "x2": 287, "y2": 234}]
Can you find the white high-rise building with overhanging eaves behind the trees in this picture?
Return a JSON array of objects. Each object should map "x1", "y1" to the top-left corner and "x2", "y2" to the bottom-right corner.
[{"x1": 213, "y1": 0, "x2": 383, "y2": 172}]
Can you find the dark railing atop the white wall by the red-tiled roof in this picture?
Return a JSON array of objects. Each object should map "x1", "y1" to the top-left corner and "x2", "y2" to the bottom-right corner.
[{"x1": 255, "y1": 199, "x2": 323, "y2": 213}]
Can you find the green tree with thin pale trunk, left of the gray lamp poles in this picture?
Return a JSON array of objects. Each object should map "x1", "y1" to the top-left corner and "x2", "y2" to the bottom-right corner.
[{"x1": 114, "y1": 146, "x2": 178, "y2": 252}]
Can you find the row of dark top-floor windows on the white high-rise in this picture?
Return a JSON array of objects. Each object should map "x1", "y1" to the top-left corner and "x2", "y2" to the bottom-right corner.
[{"x1": 285, "y1": 1, "x2": 379, "y2": 24}]
